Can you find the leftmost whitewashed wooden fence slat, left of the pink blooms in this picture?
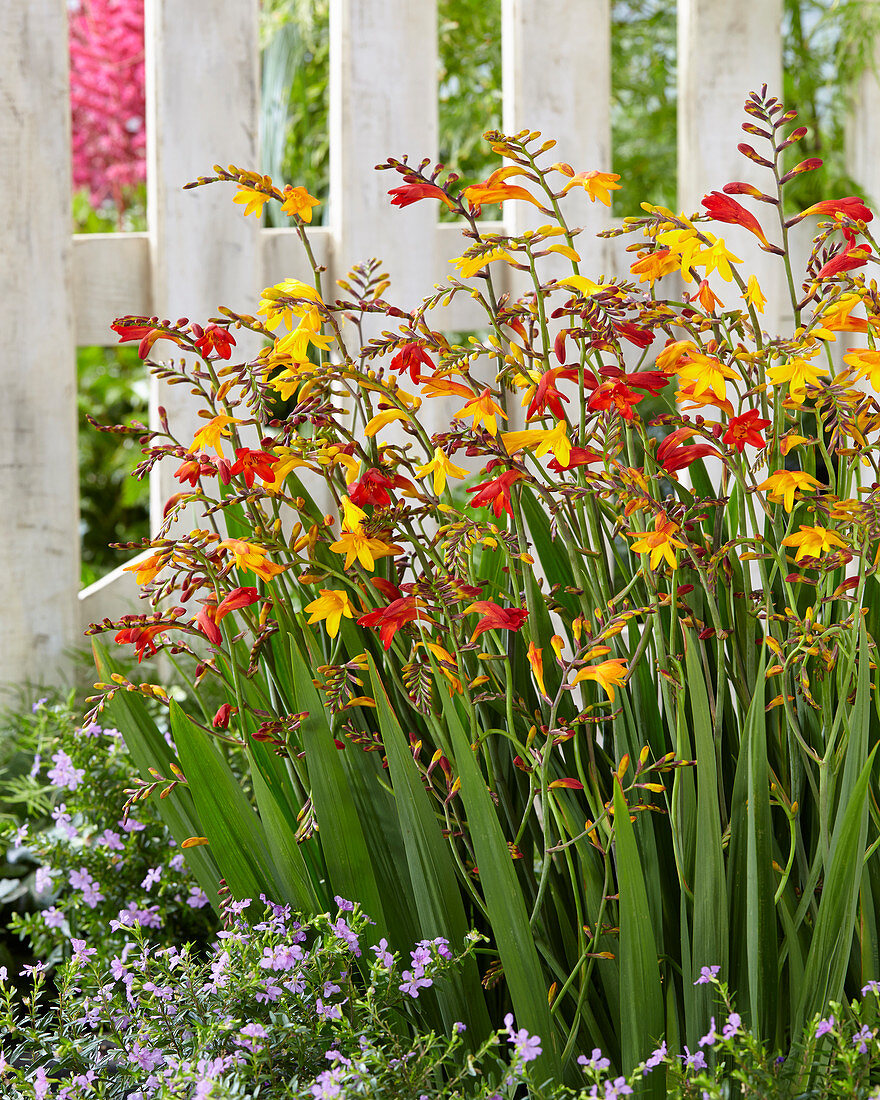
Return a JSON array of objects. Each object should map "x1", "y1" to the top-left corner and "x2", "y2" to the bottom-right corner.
[{"x1": 0, "y1": 0, "x2": 79, "y2": 694}]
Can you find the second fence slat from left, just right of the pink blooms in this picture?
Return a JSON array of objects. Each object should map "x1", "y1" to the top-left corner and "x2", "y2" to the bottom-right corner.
[{"x1": 145, "y1": 0, "x2": 262, "y2": 528}]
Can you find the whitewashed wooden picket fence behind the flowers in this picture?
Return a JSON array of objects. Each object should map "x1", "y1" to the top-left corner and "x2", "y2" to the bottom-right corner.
[{"x1": 0, "y1": 0, "x2": 880, "y2": 685}]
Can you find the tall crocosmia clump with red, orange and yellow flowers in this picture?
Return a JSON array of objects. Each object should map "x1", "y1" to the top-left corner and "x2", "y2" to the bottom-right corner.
[{"x1": 87, "y1": 89, "x2": 880, "y2": 1097}]
